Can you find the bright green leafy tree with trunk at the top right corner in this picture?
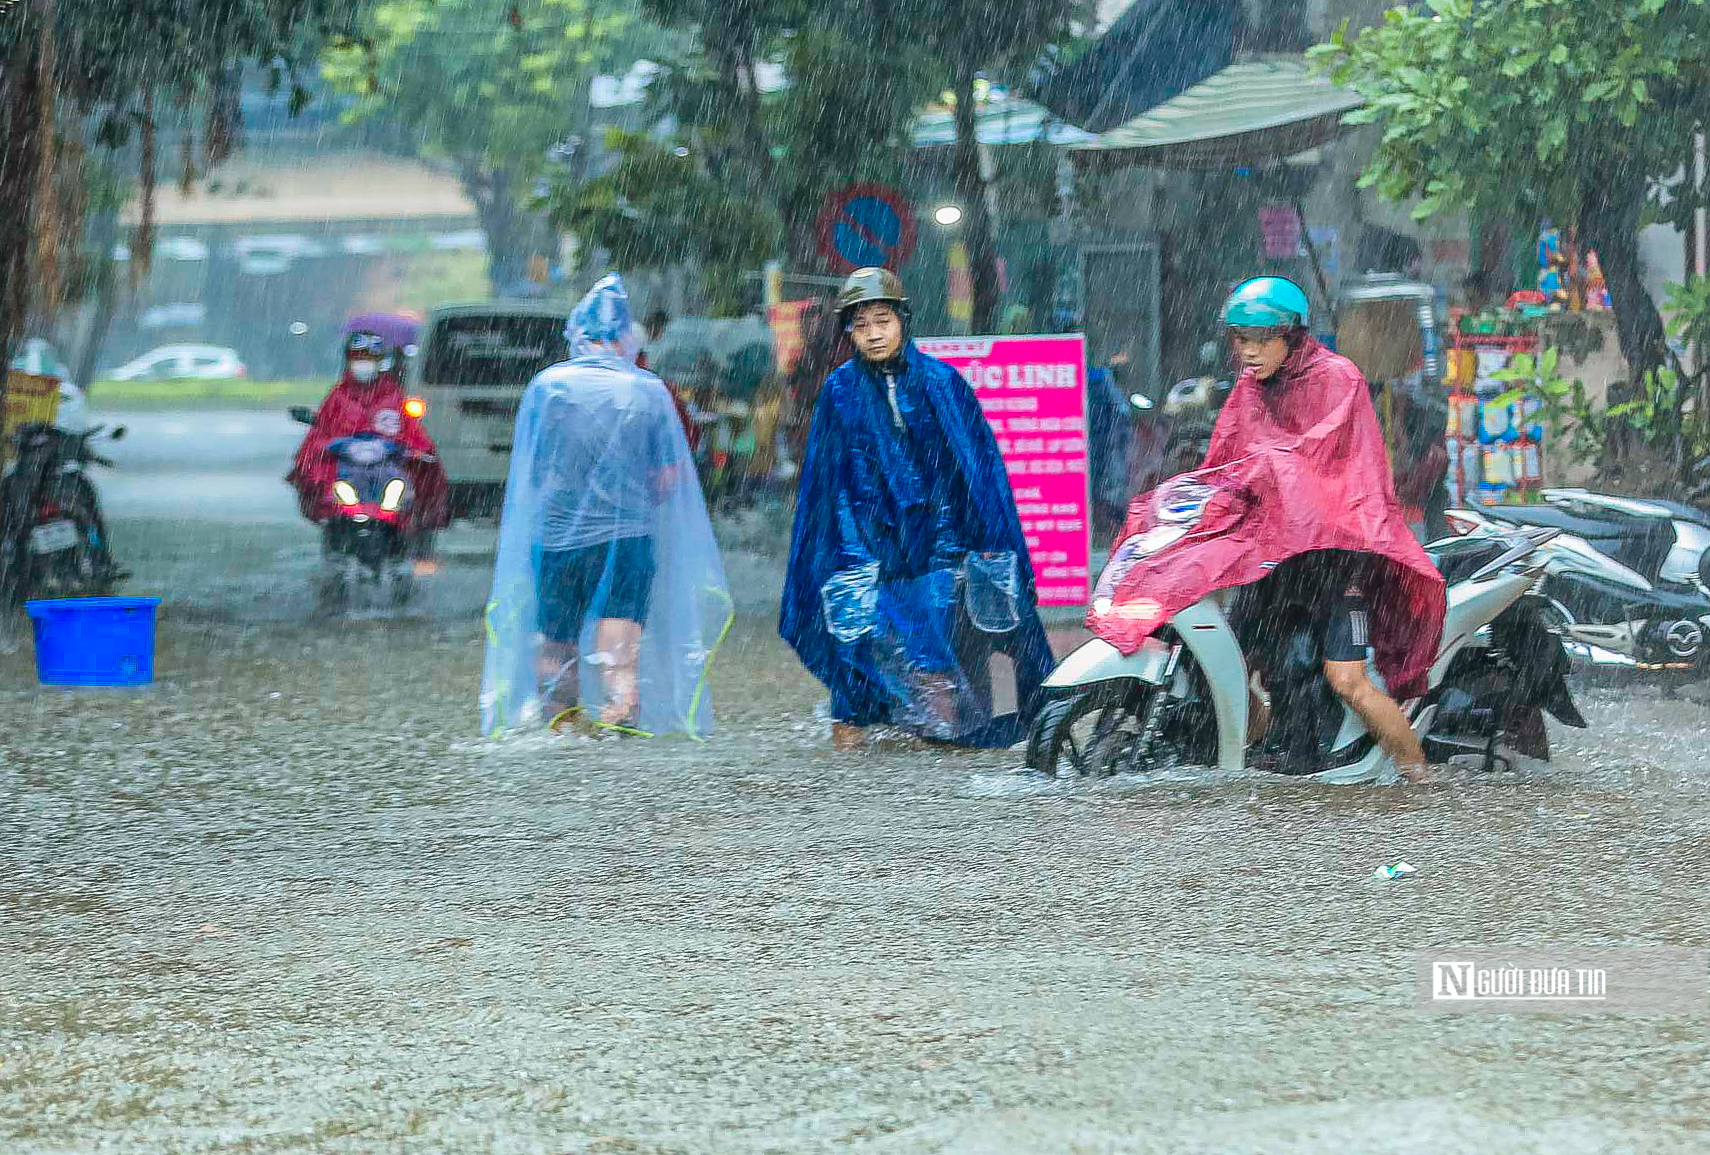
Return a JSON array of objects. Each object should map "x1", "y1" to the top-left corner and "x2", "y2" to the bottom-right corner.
[{"x1": 1315, "y1": 0, "x2": 1710, "y2": 468}]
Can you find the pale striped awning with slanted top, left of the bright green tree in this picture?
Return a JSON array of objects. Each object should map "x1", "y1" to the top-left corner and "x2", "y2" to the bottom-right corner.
[{"x1": 1069, "y1": 56, "x2": 1365, "y2": 169}]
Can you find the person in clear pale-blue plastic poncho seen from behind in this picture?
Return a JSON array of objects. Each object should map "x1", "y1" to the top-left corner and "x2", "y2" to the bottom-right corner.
[{"x1": 481, "y1": 274, "x2": 732, "y2": 737}]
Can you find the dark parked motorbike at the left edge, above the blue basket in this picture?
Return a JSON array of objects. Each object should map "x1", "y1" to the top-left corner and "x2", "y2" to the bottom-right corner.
[{"x1": 0, "y1": 423, "x2": 130, "y2": 614}]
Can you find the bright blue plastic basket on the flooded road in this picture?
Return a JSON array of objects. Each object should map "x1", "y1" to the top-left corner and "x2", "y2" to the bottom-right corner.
[{"x1": 24, "y1": 597, "x2": 161, "y2": 686}]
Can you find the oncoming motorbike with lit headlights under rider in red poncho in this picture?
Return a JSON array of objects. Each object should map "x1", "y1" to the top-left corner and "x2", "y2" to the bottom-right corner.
[{"x1": 291, "y1": 406, "x2": 433, "y2": 613}]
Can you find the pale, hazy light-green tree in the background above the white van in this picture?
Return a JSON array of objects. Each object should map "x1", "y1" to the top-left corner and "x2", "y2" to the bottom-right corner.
[{"x1": 323, "y1": 0, "x2": 660, "y2": 289}]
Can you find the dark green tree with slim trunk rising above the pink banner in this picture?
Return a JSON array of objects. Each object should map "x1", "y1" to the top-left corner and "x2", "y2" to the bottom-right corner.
[{"x1": 551, "y1": 0, "x2": 1082, "y2": 319}]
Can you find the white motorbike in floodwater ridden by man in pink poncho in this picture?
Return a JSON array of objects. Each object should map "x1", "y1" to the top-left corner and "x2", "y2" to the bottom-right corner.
[{"x1": 1028, "y1": 516, "x2": 1585, "y2": 784}]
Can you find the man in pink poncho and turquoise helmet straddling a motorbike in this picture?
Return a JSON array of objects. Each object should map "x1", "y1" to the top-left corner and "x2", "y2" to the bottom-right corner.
[{"x1": 1088, "y1": 277, "x2": 1445, "y2": 779}]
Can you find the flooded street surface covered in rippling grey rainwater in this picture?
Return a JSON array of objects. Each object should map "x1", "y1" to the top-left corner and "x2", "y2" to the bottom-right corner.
[{"x1": 0, "y1": 410, "x2": 1710, "y2": 1155}]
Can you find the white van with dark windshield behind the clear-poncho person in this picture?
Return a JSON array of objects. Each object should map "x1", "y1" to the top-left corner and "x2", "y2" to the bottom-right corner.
[{"x1": 409, "y1": 301, "x2": 569, "y2": 517}]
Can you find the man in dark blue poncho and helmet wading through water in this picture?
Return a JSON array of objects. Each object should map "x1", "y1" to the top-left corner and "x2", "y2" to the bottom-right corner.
[{"x1": 778, "y1": 269, "x2": 1052, "y2": 749}]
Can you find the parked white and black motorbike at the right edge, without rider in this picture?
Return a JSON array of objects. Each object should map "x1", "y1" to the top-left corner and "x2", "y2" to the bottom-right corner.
[{"x1": 1448, "y1": 489, "x2": 1710, "y2": 679}]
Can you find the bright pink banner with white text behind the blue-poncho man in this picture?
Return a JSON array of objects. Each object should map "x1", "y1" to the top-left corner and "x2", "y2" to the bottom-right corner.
[{"x1": 917, "y1": 334, "x2": 1091, "y2": 606}]
